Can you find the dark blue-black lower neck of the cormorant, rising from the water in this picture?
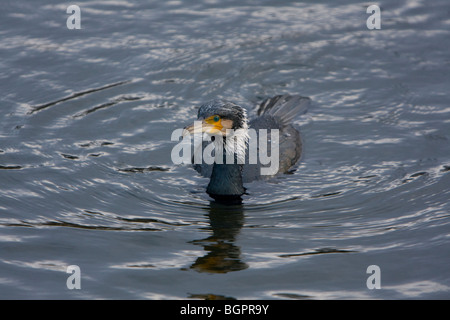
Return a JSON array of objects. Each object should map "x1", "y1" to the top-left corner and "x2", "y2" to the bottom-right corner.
[{"x1": 206, "y1": 140, "x2": 245, "y2": 198}]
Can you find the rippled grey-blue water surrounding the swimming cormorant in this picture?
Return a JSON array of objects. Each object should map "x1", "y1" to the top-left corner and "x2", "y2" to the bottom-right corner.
[{"x1": 0, "y1": 0, "x2": 450, "y2": 299}]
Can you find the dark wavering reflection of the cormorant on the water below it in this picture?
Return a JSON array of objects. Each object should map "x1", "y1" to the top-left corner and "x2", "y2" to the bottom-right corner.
[{"x1": 191, "y1": 200, "x2": 248, "y2": 273}]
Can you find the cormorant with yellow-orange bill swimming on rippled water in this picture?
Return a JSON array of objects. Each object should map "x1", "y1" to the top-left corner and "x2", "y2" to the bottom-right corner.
[{"x1": 183, "y1": 94, "x2": 311, "y2": 202}]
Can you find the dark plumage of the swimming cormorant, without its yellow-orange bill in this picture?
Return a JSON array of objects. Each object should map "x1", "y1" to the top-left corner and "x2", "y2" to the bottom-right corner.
[{"x1": 186, "y1": 95, "x2": 310, "y2": 198}]
